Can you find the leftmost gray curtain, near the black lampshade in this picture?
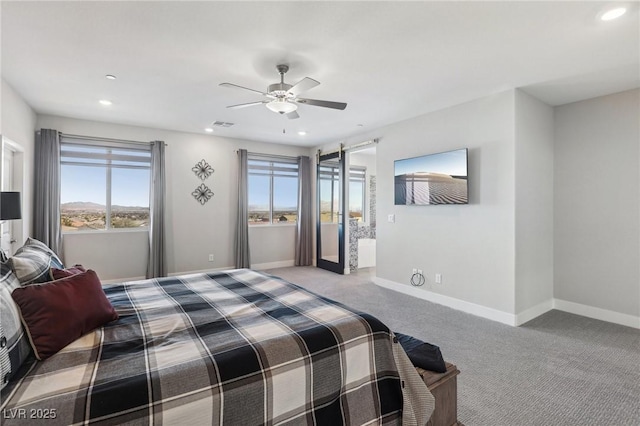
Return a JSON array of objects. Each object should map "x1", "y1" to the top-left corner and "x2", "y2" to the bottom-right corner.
[{"x1": 33, "y1": 129, "x2": 62, "y2": 257}]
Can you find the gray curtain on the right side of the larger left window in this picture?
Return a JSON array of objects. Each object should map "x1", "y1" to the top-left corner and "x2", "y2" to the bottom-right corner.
[{"x1": 147, "y1": 141, "x2": 167, "y2": 278}]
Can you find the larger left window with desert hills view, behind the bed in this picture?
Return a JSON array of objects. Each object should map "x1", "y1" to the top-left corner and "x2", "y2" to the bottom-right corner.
[{"x1": 60, "y1": 136, "x2": 151, "y2": 232}]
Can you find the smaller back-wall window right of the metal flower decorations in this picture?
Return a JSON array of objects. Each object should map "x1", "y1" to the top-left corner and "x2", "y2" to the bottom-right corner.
[{"x1": 248, "y1": 154, "x2": 298, "y2": 225}]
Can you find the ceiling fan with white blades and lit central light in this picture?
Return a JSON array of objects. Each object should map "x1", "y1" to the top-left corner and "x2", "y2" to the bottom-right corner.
[{"x1": 220, "y1": 65, "x2": 347, "y2": 119}]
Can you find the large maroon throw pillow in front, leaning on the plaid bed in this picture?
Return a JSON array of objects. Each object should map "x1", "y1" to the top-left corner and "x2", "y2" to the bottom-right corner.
[{"x1": 11, "y1": 269, "x2": 118, "y2": 360}]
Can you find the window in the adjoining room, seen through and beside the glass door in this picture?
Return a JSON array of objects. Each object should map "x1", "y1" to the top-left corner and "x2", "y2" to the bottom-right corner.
[{"x1": 320, "y1": 163, "x2": 367, "y2": 223}]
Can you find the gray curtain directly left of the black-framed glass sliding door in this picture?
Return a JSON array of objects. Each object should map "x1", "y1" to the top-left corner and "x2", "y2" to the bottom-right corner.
[{"x1": 295, "y1": 157, "x2": 313, "y2": 266}]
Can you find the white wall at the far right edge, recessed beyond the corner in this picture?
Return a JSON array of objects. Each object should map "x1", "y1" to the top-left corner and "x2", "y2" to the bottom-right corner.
[{"x1": 554, "y1": 90, "x2": 640, "y2": 327}]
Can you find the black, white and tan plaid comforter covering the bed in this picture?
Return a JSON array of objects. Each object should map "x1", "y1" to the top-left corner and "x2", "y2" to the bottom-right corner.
[{"x1": 1, "y1": 269, "x2": 433, "y2": 426}]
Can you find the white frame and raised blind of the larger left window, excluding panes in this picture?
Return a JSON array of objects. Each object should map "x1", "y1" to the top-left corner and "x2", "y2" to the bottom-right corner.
[{"x1": 60, "y1": 135, "x2": 151, "y2": 235}]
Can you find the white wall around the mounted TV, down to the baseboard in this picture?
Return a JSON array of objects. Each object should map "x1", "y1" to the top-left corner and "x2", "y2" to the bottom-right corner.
[{"x1": 371, "y1": 90, "x2": 515, "y2": 315}]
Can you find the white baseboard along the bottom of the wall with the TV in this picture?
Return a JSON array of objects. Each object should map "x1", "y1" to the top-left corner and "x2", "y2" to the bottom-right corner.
[{"x1": 373, "y1": 277, "x2": 517, "y2": 325}]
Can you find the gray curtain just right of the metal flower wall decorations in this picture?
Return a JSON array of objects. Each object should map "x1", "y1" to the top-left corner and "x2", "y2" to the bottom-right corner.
[{"x1": 235, "y1": 149, "x2": 251, "y2": 268}]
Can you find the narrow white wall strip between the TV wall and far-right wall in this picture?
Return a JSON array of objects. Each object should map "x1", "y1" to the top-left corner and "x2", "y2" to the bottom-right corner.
[{"x1": 515, "y1": 90, "x2": 554, "y2": 323}]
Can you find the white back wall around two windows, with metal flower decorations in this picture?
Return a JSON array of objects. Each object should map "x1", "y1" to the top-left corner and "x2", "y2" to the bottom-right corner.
[{"x1": 37, "y1": 116, "x2": 309, "y2": 280}]
